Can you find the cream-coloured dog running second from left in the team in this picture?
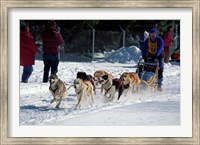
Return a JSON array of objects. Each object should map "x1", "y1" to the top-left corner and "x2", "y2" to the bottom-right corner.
[{"x1": 74, "y1": 78, "x2": 94, "y2": 108}]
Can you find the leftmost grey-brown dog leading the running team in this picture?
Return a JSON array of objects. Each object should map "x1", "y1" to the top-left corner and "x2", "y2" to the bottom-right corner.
[{"x1": 49, "y1": 74, "x2": 67, "y2": 108}]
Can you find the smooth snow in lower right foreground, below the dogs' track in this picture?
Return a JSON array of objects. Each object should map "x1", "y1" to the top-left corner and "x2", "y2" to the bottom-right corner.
[{"x1": 50, "y1": 101, "x2": 180, "y2": 126}]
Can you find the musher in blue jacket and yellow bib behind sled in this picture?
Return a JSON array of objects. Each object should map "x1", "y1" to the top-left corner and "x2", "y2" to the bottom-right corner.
[{"x1": 142, "y1": 28, "x2": 164, "y2": 91}]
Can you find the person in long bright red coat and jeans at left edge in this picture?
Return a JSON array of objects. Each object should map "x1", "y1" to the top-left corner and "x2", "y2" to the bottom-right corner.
[{"x1": 20, "y1": 24, "x2": 37, "y2": 83}]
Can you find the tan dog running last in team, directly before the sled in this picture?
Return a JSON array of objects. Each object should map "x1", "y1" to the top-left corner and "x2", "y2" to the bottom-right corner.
[{"x1": 120, "y1": 72, "x2": 141, "y2": 95}]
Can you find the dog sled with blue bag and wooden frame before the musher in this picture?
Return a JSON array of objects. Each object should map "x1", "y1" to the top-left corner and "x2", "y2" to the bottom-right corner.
[{"x1": 136, "y1": 59, "x2": 159, "y2": 88}]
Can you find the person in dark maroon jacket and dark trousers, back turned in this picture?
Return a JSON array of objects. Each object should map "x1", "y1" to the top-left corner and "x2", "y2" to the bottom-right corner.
[{"x1": 41, "y1": 21, "x2": 64, "y2": 83}]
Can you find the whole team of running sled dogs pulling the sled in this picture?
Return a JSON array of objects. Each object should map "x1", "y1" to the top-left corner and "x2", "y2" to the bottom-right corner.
[{"x1": 49, "y1": 70, "x2": 141, "y2": 108}]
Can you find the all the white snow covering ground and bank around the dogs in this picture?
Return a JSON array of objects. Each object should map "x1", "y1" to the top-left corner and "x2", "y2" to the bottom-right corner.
[{"x1": 19, "y1": 46, "x2": 180, "y2": 126}]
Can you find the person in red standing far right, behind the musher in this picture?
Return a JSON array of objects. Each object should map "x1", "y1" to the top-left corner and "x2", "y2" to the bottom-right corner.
[{"x1": 163, "y1": 26, "x2": 173, "y2": 63}]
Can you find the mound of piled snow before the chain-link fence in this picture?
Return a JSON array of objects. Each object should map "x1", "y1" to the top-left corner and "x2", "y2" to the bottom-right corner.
[{"x1": 105, "y1": 46, "x2": 141, "y2": 63}]
